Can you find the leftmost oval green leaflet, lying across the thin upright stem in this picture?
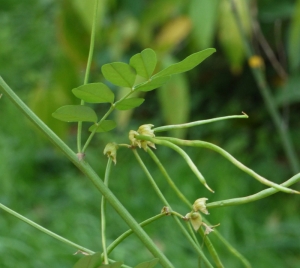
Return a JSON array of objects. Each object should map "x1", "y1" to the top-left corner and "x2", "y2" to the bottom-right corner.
[{"x1": 52, "y1": 105, "x2": 97, "y2": 122}]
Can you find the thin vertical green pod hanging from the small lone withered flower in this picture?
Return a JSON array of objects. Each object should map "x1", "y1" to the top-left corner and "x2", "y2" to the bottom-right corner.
[{"x1": 101, "y1": 157, "x2": 112, "y2": 264}]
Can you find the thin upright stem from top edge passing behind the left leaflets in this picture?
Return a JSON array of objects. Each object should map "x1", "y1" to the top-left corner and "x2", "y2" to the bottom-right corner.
[{"x1": 77, "y1": 0, "x2": 98, "y2": 153}]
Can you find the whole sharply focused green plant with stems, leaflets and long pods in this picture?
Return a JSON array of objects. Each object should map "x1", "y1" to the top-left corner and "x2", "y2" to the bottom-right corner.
[{"x1": 0, "y1": 1, "x2": 300, "y2": 268}]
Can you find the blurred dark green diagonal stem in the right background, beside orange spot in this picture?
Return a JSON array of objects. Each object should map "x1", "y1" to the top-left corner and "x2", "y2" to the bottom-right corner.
[{"x1": 230, "y1": 0, "x2": 300, "y2": 173}]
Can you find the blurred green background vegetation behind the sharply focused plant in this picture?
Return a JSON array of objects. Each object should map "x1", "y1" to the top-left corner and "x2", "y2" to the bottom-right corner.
[{"x1": 0, "y1": 0, "x2": 300, "y2": 268}]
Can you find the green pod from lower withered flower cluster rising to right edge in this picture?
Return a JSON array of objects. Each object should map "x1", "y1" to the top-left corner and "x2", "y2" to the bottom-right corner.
[{"x1": 206, "y1": 173, "x2": 300, "y2": 208}]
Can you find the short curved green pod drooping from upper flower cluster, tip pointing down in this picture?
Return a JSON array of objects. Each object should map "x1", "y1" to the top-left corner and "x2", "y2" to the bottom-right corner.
[{"x1": 135, "y1": 135, "x2": 214, "y2": 193}]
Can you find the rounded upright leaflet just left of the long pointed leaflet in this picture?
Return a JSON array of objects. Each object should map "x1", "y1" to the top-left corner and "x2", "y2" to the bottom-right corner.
[{"x1": 130, "y1": 48, "x2": 157, "y2": 79}]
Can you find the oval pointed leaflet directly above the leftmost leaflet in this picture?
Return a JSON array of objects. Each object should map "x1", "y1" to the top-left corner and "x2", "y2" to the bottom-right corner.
[{"x1": 72, "y1": 83, "x2": 114, "y2": 103}]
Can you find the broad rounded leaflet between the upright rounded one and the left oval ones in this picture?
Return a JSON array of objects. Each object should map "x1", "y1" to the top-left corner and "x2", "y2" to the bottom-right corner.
[{"x1": 101, "y1": 62, "x2": 136, "y2": 88}]
